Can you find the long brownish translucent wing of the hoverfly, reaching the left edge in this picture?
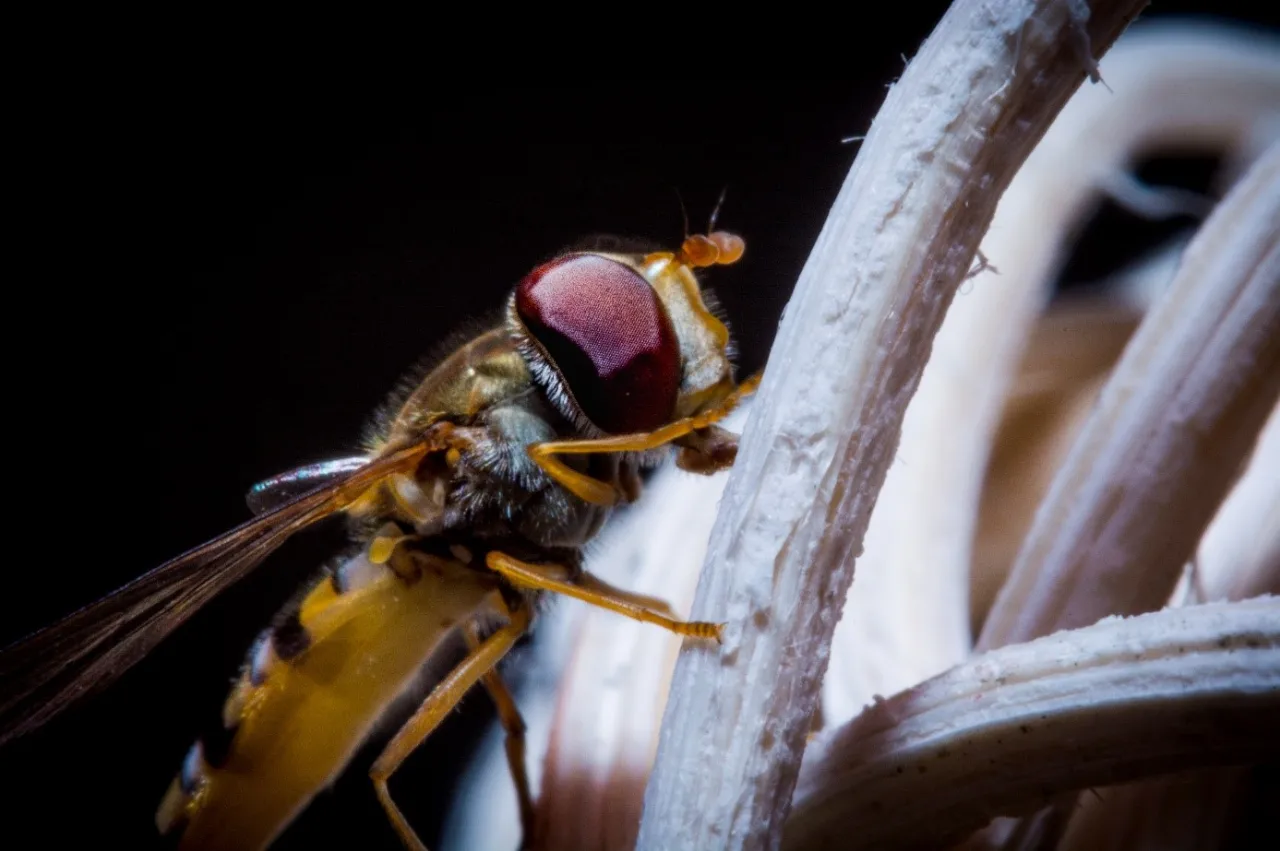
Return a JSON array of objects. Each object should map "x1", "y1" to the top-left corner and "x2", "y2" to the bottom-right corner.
[{"x1": 0, "y1": 443, "x2": 436, "y2": 745}]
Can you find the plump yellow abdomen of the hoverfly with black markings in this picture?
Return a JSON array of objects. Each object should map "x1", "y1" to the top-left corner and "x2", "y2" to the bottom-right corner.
[{"x1": 156, "y1": 534, "x2": 503, "y2": 850}]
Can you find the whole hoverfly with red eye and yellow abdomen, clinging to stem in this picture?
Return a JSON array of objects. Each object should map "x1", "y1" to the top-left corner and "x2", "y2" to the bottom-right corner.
[{"x1": 0, "y1": 232, "x2": 756, "y2": 848}]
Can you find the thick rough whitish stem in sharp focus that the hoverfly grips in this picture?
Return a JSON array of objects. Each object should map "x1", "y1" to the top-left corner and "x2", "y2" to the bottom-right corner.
[{"x1": 637, "y1": 0, "x2": 1144, "y2": 851}]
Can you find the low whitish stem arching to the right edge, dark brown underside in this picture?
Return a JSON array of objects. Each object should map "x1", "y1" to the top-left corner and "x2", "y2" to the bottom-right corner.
[{"x1": 785, "y1": 598, "x2": 1280, "y2": 851}]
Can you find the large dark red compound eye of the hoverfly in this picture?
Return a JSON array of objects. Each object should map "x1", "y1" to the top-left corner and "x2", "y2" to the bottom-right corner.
[{"x1": 516, "y1": 255, "x2": 680, "y2": 434}]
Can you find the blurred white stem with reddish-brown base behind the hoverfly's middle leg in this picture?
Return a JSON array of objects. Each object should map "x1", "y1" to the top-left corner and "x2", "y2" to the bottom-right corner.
[{"x1": 527, "y1": 460, "x2": 733, "y2": 851}]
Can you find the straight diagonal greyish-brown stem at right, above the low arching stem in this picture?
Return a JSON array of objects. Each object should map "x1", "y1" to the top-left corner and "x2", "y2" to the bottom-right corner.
[{"x1": 979, "y1": 145, "x2": 1280, "y2": 648}]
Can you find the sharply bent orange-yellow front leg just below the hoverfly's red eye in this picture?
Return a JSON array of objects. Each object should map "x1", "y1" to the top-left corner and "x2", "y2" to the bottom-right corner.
[{"x1": 529, "y1": 375, "x2": 760, "y2": 505}]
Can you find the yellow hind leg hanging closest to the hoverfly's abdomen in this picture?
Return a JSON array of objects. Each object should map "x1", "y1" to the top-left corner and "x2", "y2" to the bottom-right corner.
[{"x1": 369, "y1": 605, "x2": 530, "y2": 851}]
